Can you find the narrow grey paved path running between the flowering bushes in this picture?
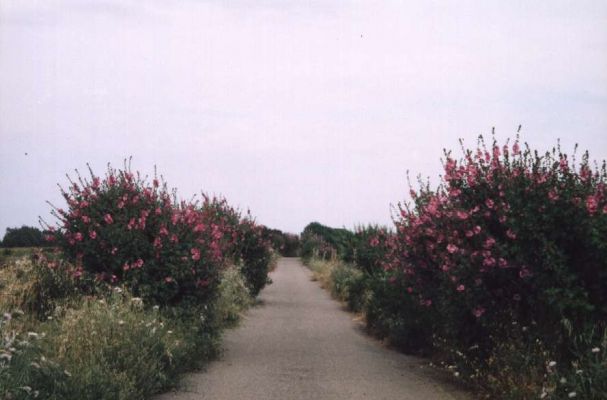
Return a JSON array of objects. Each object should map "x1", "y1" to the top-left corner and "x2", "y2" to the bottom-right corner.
[{"x1": 157, "y1": 258, "x2": 470, "y2": 400}]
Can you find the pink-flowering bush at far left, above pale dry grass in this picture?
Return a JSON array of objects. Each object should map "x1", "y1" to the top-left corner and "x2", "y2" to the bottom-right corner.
[{"x1": 45, "y1": 167, "x2": 227, "y2": 305}]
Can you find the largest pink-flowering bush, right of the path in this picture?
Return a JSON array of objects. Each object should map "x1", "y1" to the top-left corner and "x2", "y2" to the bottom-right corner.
[{"x1": 390, "y1": 138, "x2": 607, "y2": 388}]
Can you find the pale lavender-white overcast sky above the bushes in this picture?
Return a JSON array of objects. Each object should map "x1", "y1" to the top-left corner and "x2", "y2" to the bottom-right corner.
[{"x1": 0, "y1": 0, "x2": 607, "y2": 235}]
